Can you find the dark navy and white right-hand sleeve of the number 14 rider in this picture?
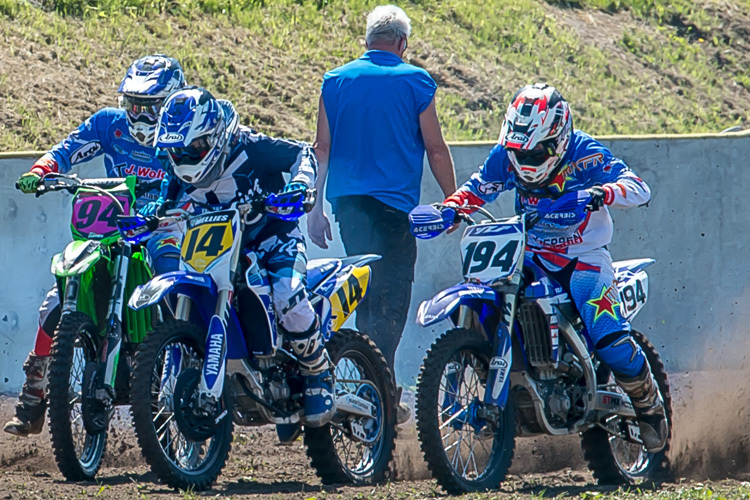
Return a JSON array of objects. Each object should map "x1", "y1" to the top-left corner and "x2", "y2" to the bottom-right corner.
[{"x1": 249, "y1": 133, "x2": 318, "y2": 188}]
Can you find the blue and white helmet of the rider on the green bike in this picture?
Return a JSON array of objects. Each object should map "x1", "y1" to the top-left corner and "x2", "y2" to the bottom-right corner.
[{"x1": 118, "y1": 54, "x2": 187, "y2": 146}]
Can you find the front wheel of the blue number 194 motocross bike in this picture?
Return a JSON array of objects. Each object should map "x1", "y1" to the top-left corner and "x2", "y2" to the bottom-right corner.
[{"x1": 417, "y1": 328, "x2": 515, "y2": 495}]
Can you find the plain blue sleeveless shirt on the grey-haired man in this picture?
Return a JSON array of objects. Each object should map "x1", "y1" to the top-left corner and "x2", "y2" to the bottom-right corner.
[{"x1": 322, "y1": 50, "x2": 437, "y2": 212}]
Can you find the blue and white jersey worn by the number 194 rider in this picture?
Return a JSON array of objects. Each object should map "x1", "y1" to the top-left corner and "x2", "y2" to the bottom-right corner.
[{"x1": 457, "y1": 130, "x2": 651, "y2": 255}]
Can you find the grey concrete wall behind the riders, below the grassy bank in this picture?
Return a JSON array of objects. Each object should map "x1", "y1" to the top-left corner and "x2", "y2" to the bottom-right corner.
[{"x1": 0, "y1": 135, "x2": 750, "y2": 392}]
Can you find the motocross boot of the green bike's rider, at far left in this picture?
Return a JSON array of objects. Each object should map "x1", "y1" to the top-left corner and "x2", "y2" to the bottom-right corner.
[{"x1": 3, "y1": 354, "x2": 50, "y2": 437}]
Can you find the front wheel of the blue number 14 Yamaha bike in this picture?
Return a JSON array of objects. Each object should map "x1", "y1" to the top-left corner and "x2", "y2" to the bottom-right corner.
[{"x1": 130, "y1": 320, "x2": 232, "y2": 491}]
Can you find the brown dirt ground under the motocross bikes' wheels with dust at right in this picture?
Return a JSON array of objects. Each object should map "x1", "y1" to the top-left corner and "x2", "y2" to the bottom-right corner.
[{"x1": 0, "y1": 372, "x2": 750, "y2": 500}]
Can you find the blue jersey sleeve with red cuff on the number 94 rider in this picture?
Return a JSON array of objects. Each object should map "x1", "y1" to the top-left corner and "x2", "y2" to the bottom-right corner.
[{"x1": 31, "y1": 108, "x2": 112, "y2": 175}]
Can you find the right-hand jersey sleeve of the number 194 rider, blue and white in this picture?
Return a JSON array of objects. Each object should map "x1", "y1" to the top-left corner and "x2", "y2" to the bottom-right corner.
[{"x1": 578, "y1": 139, "x2": 651, "y2": 208}]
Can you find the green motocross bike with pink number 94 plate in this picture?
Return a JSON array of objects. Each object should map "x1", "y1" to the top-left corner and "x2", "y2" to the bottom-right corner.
[{"x1": 21, "y1": 173, "x2": 158, "y2": 481}]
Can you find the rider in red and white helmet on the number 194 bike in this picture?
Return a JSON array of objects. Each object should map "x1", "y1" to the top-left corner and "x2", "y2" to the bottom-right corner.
[{"x1": 445, "y1": 83, "x2": 668, "y2": 452}]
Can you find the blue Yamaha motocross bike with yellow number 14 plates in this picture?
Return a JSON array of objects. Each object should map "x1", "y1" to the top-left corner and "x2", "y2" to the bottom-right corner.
[{"x1": 121, "y1": 191, "x2": 395, "y2": 490}]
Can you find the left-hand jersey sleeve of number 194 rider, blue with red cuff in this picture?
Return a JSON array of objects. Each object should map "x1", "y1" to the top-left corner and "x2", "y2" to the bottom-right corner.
[{"x1": 445, "y1": 146, "x2": 507, "y2": 206}]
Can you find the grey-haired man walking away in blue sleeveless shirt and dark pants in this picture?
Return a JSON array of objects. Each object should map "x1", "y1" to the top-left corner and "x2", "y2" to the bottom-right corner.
[{"x1": 307, "y1": 5, "x2": 456, "y2": 422}]
